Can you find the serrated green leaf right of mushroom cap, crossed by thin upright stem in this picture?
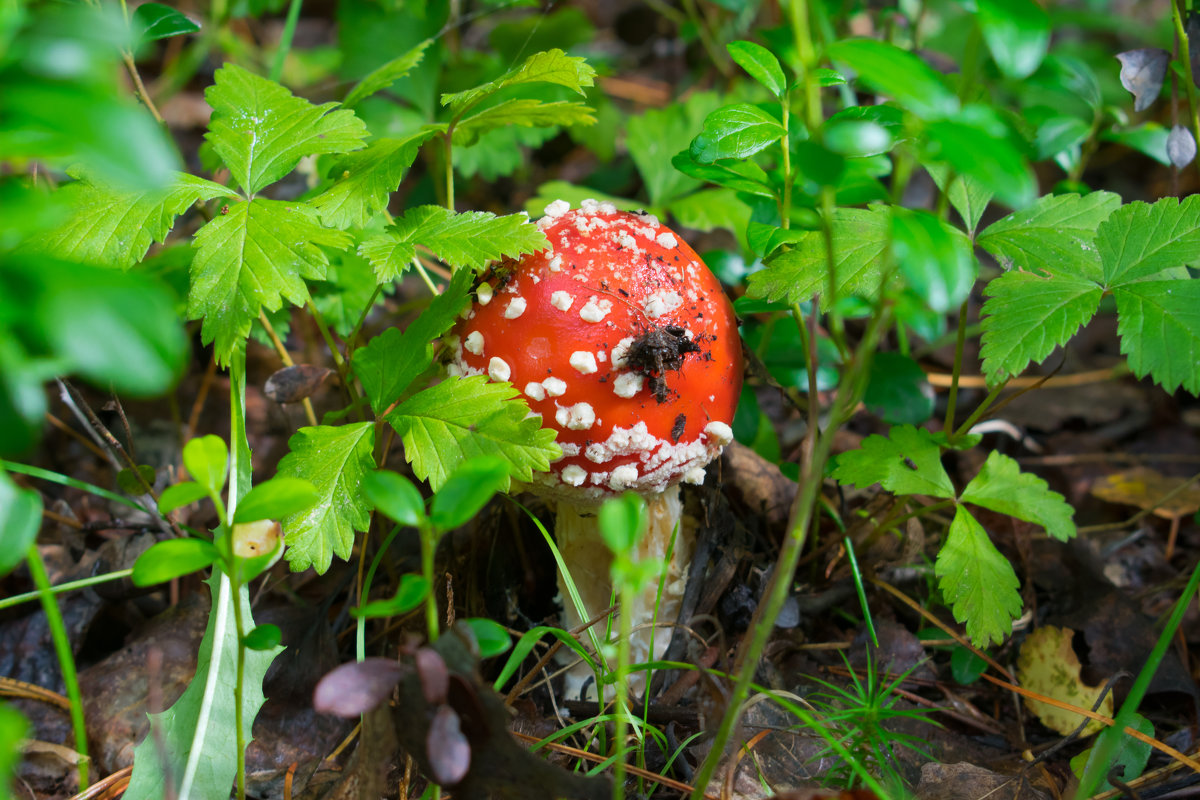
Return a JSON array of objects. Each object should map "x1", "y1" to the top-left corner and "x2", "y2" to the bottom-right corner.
[{"x1": 746, "y1": 207, "x2": 892, "y2": 311}]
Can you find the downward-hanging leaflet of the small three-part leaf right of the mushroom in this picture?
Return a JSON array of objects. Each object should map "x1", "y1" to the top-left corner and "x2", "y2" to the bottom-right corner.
[{"x1": 934, "y1": 506, "x2": 1021, "y2": 648}]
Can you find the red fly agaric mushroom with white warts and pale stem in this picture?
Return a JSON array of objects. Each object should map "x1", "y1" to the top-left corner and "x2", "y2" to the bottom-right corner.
[{"x1": 449, "y1": 200, "x2": 742, "y2": 693}]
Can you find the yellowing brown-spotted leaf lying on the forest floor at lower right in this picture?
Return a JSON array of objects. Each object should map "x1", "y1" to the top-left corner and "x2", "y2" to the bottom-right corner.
[{"x1": 1016, "y1": 625, "x2": 1112, "y2": 736}]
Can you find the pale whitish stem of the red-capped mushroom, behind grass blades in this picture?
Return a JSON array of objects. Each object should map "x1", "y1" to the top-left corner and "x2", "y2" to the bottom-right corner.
[{"x1": 554, "y1": 486, "x2": 695, "y2": 698}]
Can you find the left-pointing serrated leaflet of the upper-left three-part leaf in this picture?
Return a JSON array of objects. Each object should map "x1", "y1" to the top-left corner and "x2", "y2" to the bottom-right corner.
[{"x1": 32, "y1": 173, "x2": 238, "y2": 269}]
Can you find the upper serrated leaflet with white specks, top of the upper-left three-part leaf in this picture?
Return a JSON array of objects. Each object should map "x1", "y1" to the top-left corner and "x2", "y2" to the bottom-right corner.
[{"x1": 204, "y1": 61, "x2": 367, "y2": 196}]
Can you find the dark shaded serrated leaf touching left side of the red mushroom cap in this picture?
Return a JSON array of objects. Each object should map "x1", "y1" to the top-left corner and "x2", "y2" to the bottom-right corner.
[{"x1": 353, "y1": 270, "x2": 472, "y2": 414}]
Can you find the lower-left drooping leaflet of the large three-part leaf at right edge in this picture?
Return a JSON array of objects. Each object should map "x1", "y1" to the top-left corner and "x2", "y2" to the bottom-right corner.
[{"x1": 979, "y1": 271, "x2": 1104, "y2": 386}]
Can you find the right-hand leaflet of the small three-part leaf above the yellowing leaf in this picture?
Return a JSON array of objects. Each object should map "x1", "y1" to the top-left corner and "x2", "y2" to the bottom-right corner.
[{"x1": 959, "y1": 450, "x2": 1075, "y2": 542}]
